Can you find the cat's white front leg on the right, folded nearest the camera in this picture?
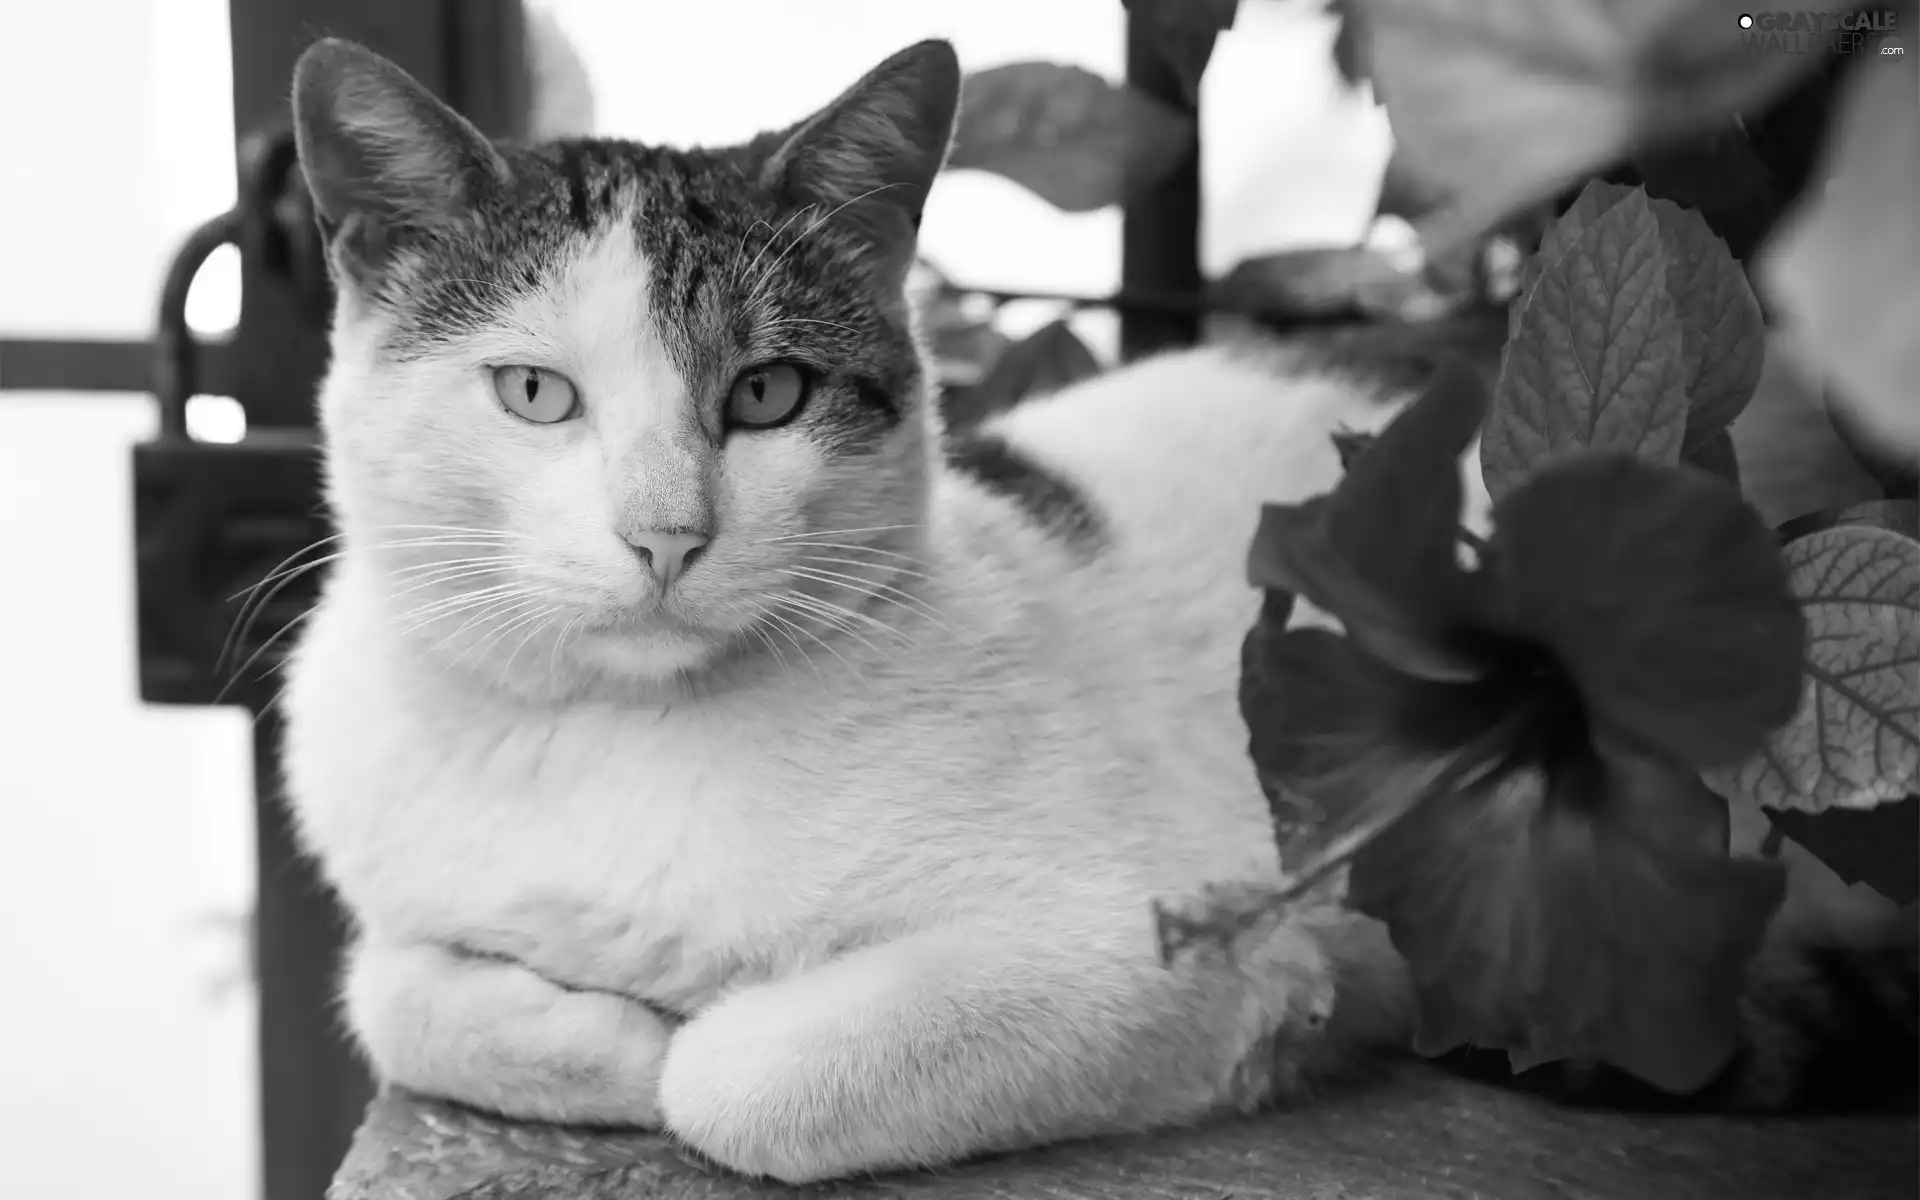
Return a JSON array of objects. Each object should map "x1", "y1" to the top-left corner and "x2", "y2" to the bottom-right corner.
[{"x1": 660, "y1": 904, "x2": 1332, "y2": 1183}]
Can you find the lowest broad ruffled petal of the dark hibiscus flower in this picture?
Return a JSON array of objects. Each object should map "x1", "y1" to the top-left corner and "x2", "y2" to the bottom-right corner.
[{"x1": 1348, "y1": 733, "x2": 1786, "y2": 1092}]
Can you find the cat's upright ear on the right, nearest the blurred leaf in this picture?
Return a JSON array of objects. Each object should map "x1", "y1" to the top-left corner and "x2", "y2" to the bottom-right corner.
[{"x1": 760, "y1": 40, "x2": 960, "y2": 250}]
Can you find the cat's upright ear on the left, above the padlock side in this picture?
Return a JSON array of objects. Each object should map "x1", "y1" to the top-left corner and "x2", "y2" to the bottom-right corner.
[{"x1": 294, "y1": 38, "x2": 507, "y2": 267}]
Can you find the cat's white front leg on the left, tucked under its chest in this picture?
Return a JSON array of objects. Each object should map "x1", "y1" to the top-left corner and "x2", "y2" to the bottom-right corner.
[{"x1": 346, "y1": 937, "x2": 672, "y2": 1127}]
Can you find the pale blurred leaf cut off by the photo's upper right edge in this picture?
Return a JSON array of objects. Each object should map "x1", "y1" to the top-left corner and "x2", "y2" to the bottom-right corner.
[{"x1": 1759, "y1": 43, "x2": 1920, "y2": 455}]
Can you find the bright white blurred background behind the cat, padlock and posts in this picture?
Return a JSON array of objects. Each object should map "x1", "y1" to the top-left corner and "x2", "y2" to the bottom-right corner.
[{"x1": 0, "y1": 0, "x2": 1388, "y2": 1200}]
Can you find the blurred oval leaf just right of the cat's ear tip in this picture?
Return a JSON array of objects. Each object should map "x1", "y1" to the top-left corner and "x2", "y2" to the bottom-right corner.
[{"x1": 947, "y1": 61, "x2": 1194, "y2": 213}]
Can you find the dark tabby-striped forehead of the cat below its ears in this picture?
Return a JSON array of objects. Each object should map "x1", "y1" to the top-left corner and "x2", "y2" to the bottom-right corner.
[{"x1": 372, "y1": 132, "x2": 922, "y2": 447}]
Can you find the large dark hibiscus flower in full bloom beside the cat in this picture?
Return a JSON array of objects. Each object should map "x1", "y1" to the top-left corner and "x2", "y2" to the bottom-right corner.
[{"x1": 1240, "y1": 353, "x2": 1807, "y2": 1092}]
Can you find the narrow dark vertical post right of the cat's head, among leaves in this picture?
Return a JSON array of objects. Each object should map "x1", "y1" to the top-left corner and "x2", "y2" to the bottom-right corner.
[{"x1": 1119, "y1": 6, "x2": 1202, "y2": 359}]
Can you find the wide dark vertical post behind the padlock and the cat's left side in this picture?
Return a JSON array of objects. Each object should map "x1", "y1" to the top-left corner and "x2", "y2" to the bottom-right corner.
[{"x1": 228, "y1": 9, "x2": 526, "y2": 1200}]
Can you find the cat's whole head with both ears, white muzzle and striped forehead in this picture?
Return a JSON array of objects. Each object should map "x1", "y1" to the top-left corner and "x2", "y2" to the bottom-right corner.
[{"x1": 296, "y1": 42, "x2": 958, "y2": 689}]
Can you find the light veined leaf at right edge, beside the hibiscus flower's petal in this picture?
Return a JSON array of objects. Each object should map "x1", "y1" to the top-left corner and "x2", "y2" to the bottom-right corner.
[{"x1": 1707, "y1": 526, "x2": 1920, "y2": 812}]
